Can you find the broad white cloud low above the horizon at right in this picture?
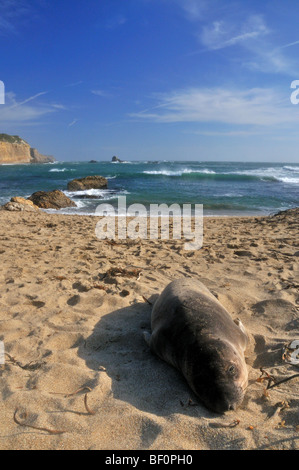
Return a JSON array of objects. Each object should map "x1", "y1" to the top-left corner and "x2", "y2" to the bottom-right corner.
[{"x1": 130, "y1": 88, "x2": 299, "y2": 126}]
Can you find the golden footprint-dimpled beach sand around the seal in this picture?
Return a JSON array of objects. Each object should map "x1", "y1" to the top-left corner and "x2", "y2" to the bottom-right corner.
[{"x1": 0, "y1": 210, "x2": 299, "y2": 450}]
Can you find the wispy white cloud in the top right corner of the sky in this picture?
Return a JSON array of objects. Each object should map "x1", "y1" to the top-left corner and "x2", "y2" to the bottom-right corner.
[{"x1": 176, "y1": 0, "x2": 299, "y2": 76}]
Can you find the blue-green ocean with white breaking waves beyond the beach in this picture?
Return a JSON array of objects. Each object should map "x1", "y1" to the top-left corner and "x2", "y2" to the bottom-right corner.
[{"x1": 0, "y1": 161, "x2": 299, "y2": 216}]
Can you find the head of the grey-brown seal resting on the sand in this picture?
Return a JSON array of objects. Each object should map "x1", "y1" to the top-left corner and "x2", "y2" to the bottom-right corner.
[{"x1": 186, "y1": 340, "x2": 248, "y2": 413}]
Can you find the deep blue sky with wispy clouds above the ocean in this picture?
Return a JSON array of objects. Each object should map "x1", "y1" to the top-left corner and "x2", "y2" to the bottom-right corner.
[{"x1": 0, "y1": 0, "x2": 299, "y2": 162}]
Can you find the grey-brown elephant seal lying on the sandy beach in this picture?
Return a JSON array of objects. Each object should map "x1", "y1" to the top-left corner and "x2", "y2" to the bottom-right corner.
[{"x1": 144, "y1": 278, "x2": 249, "y2": 413}]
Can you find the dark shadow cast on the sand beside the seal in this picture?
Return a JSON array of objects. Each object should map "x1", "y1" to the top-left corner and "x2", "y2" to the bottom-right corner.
[{"x1": 78, "y1": 299, "x2": 216, "y2": 417}]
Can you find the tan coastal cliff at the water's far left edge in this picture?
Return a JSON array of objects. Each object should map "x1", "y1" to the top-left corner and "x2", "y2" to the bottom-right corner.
[{"x1": 0, "y1": 134, "x2": 55, "y2": 165}]
